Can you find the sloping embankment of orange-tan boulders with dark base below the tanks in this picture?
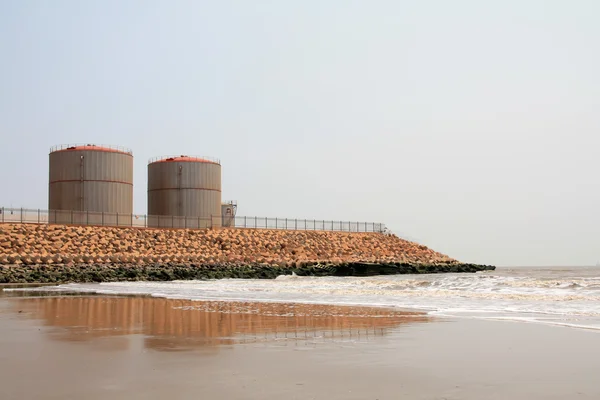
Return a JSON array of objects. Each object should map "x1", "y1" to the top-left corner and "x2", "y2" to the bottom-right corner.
[{"x1": 0, "y1": 224, "x2": 493, "y2": 282}]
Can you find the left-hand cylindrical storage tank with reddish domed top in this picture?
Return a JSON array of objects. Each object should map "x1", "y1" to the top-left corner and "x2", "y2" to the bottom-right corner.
[{"x1": 48, "y1": 144, "x2": 133, "y2": 226}]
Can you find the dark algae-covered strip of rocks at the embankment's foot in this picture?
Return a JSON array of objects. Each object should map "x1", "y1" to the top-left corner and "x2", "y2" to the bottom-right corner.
[{"x1": 0, "y1": 263, "x2": 496, "y2": 283}]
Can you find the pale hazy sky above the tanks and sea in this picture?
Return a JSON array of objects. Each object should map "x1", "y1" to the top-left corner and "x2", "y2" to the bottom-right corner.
[{"x1": 0, "y1": 0, "x2": 600, "y2": 265}]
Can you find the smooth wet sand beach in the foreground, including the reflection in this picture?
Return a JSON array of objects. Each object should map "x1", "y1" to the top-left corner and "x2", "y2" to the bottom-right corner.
[{"x1": 0, "y1": 296, "x2": 600, "y2": 400}]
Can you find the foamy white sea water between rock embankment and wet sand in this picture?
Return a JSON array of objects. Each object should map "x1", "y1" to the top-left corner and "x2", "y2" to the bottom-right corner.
[{"x1": 8, "y1": 268, "x2": 600, "y2": 330}]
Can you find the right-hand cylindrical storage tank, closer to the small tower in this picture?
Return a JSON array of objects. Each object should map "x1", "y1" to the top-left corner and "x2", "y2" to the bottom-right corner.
[{"x1": 148, "y1": 156, "x2": 221, "y2": 228}]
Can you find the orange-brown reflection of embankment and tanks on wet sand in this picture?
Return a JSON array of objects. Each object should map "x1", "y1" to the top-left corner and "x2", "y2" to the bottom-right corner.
[{"x1": 12, "y1": 296, "x2": 430, "y2": 350}]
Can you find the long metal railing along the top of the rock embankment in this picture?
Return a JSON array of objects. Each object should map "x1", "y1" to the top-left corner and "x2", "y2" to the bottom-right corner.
[{"x1": 0, "y1": 207, "x2": 387, "y2": 233}]
